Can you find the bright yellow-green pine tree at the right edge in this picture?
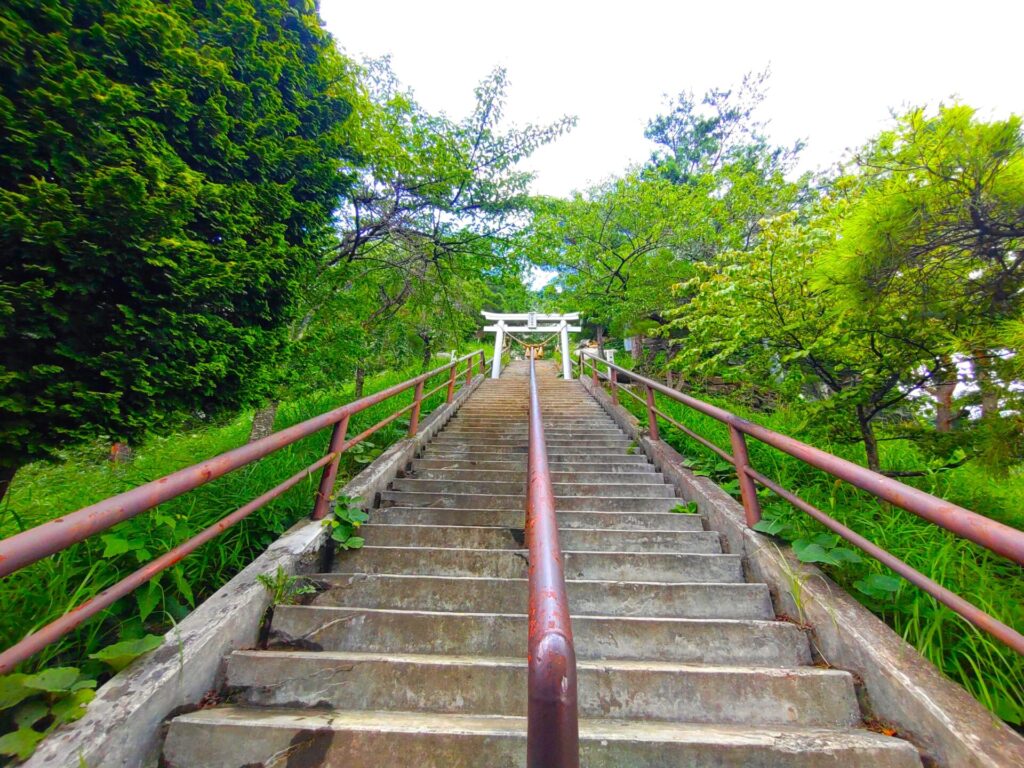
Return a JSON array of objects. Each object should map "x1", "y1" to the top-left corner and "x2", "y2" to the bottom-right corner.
[{"x1": 826, "y1": 104, "x2": 1024, "y2": 439}]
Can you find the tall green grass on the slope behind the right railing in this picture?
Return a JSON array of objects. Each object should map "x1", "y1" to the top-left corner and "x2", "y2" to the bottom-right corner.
[{"x1": 606, "y1": 382, "x2": 1024, "y2": 727}]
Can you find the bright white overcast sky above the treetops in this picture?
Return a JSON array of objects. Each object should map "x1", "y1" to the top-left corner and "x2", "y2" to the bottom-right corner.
[{"x1": 321, "y1": 0, "x2": 1024, "y2": 195}]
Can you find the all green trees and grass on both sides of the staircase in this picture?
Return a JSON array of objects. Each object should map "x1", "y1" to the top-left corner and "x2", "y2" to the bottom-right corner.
[{"x1": 0, "y1": 0, "x2": 1024, "y2": 758}]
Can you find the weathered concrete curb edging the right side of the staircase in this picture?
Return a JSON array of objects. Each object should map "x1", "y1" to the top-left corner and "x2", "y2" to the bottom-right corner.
[{"x1": 581, "y1": 378, "x2": 1024, "y2": 768}]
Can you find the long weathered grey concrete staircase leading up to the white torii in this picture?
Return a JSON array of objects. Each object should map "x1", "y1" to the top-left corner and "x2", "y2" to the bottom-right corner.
[{"x1": 164, "y1": 362, "x2": 921, "y2": 768}]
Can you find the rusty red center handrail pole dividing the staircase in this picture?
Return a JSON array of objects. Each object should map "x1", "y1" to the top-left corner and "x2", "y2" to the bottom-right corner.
[{"x1": 526, "y1": 348, "x2": 580, "y2": 768}]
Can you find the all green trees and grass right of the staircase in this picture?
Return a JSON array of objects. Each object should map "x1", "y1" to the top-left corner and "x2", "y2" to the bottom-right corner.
[{"x1": 529, "y1": 79, "x2": 1024, "y2": 724}]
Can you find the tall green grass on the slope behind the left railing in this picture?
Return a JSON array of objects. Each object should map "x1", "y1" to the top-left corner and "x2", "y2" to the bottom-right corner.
[{"x1": 0, "y1": 358, "x2": 473, "y2": 672}]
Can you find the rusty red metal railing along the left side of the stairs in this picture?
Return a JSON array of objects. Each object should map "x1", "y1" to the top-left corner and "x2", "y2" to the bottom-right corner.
[{"x1": 0, "y1": 350, "x2": 487, "y2": 675}]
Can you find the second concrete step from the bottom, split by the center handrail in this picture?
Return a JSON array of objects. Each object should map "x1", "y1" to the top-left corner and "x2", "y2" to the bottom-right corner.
[{"x1": 227, "y1": 650, "x2": 860, "y2": 728}]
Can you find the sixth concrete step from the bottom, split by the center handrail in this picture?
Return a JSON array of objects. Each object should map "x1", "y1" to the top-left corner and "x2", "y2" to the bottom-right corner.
[{"x1": 359, "y1": 521, "x2": 722, "y2": 554}]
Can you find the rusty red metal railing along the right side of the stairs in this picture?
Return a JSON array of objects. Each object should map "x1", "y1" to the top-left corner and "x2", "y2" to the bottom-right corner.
[{"x1": 580, "y1": 355, "x2": 1024, "y2": 654}]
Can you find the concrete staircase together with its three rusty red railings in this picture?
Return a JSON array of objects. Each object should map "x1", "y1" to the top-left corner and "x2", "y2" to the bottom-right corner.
[{"x1": 0, "y1": 344, "x2": 1024, "y2": 768}]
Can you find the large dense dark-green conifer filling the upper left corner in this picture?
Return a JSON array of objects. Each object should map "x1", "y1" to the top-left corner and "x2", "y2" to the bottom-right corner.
[{"x1": 0, "y1": 0, "x2": 351, "y2": 494}]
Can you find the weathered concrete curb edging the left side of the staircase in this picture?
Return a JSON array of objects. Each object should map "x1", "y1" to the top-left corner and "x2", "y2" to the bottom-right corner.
[{"x1": 25, "y1": 376, "x2": 483, "y2": 768}]
